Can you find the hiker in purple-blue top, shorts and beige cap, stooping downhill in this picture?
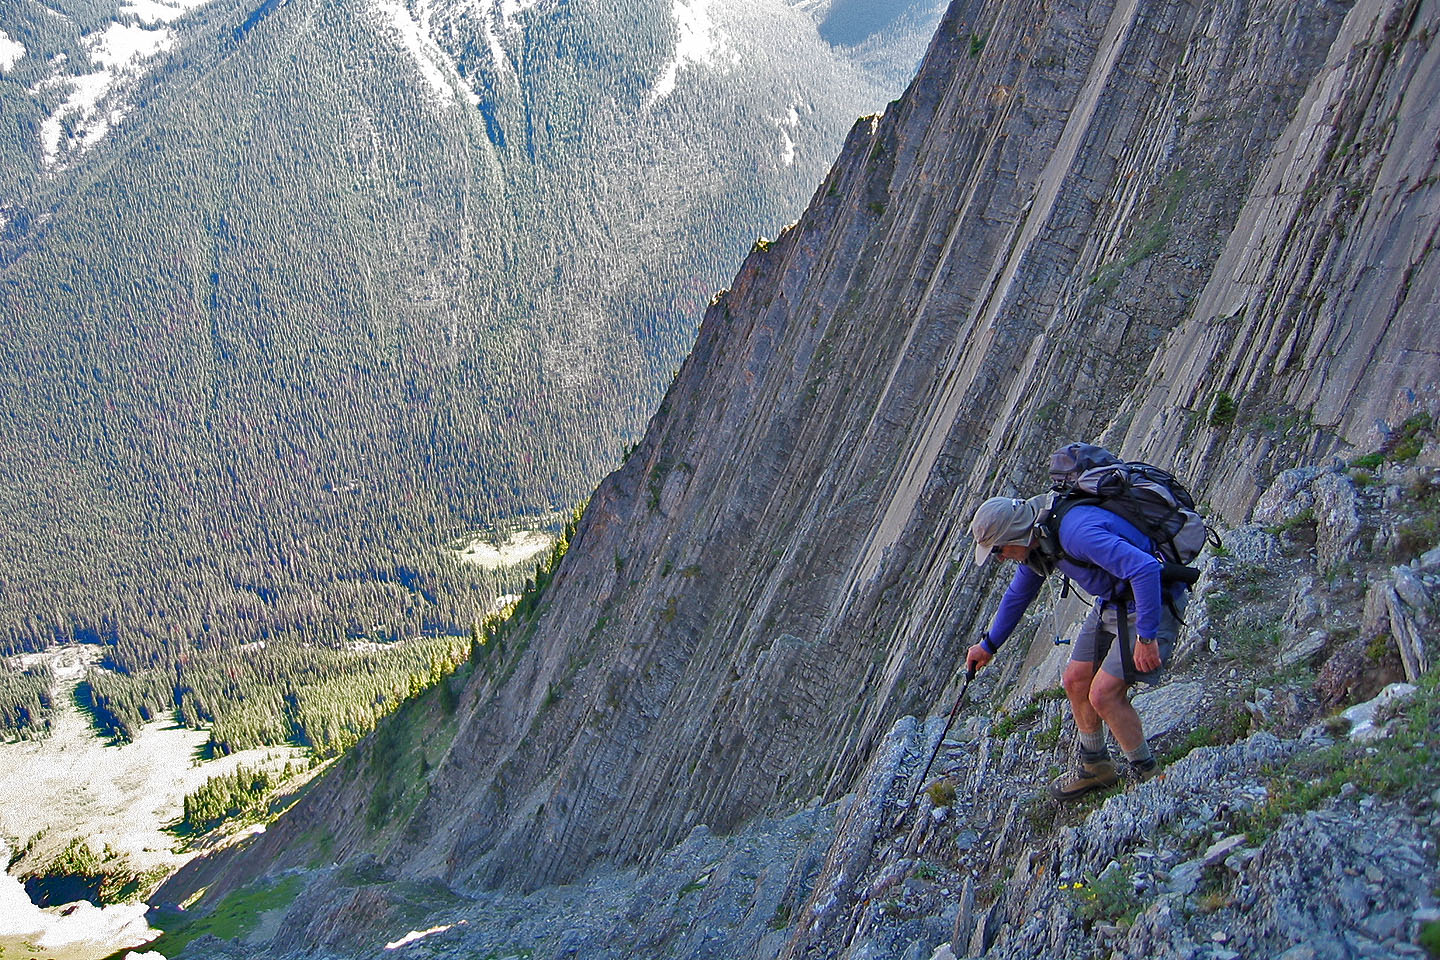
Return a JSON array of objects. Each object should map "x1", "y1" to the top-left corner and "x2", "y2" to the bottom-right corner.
[{"x1": 965, "y1": 495, "x2": 1187, "y2": 800}]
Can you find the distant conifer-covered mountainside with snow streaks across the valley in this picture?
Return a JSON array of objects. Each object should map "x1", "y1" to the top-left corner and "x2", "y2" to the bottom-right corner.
[{"x1": 0, "y1": 0, "x2": 939, "y2": 733}]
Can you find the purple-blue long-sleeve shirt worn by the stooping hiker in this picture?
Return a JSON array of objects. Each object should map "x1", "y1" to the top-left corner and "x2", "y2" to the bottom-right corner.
[{"x1": 985, "y1": 505, "x2": 1164, "y2": 653}]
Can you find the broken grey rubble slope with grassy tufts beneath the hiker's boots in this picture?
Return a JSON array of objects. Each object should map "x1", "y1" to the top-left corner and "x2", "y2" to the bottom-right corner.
[{"x1": 157, "y1": 457, "x2": 1440, "y2": 960}]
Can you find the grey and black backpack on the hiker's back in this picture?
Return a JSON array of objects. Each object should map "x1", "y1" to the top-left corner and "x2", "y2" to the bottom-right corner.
[{"x1": 1041, "y1": 443, "x2": 1212, "y2": 569}]
